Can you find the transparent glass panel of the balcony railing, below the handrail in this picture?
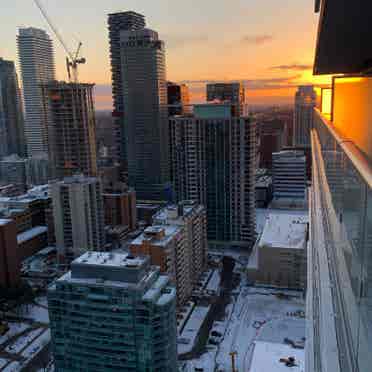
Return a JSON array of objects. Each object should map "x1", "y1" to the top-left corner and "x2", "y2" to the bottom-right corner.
[{"x1": 313, "y1": 112, "x2": 372, "y2": 371}]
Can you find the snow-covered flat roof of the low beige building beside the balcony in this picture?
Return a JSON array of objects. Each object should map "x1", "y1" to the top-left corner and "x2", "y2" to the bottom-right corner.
[{"x1": 259, "y1": 212, "x2": 308, "y2": 249}]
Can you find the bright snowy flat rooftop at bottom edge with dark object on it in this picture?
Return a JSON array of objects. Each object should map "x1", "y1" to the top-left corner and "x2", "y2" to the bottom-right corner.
[{"x1": 249, "y1": 341, "x2": 305, "y2": 372}]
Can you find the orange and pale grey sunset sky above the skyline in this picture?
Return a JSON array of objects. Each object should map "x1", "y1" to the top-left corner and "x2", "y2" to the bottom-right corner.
[{"x1": 0, "y1": 0, "x2": 327, "y2": 109}]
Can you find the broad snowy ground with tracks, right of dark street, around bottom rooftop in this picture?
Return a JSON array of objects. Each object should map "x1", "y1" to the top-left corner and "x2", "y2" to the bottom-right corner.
[{"x1": 186, "y1": 286, "x2": 305, "y2": 372}]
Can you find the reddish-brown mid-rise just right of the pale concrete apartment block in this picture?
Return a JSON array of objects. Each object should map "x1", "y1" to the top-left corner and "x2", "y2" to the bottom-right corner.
[{"x1": 102, "y1": 184, "x2": 137, "y2": 230}]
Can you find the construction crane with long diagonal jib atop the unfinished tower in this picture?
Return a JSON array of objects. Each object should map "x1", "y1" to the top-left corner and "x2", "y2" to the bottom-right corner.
[{"x1": 34, "y1": 0, "x2": 86, "y2": 83}]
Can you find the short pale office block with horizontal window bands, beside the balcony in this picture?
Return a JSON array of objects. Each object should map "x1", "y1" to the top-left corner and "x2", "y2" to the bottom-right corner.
[{"x1": 272, "y1": 150, "x2": 307, "y2": 200}]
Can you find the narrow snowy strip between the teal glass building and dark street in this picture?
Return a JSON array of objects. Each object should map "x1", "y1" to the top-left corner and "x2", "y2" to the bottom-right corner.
[{"x1": 178, "y1": 306, "x2": 210, "y2": 354}]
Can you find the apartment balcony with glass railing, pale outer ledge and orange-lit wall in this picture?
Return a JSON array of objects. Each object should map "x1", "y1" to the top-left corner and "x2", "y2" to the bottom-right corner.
[{"x1": 307, "y1": 77, "x2": 372, "y2": 372}]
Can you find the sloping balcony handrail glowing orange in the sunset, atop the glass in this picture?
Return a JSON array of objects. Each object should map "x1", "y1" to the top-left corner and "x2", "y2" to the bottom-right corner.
[{"x1": 314, "y1": 108, "x2": 372, "y2": 189}]
